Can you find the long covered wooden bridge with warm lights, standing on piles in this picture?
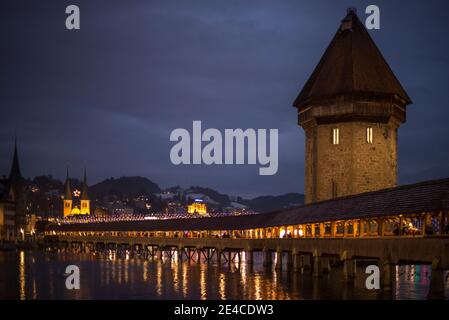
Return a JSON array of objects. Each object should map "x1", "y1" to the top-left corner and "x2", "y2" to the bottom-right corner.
[{"x1": 44, "y1": 179, "x2": 449, "y2": 294}]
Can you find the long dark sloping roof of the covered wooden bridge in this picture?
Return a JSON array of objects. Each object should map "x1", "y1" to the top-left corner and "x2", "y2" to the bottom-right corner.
[{"x1": 47, "y1": 178, "x2": 449, "y2": 231}]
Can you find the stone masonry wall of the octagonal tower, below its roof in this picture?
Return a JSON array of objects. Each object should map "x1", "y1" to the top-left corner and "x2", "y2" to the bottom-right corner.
[{"x1": 305, "y1": 122, "x2": 397, "y2": 203}]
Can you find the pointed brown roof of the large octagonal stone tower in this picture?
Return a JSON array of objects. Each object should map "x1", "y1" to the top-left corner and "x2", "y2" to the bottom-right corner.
[{"x1": 293, "y1": 9, "x2": 412, "y2": 109}]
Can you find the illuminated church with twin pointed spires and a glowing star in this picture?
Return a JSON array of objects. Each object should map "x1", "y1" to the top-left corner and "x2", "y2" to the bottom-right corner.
[{"x1": 62, "y1": 169, "x2": 90, "y2": 217}]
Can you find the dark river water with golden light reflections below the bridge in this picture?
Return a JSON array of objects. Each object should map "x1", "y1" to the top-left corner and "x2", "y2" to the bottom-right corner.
[{"x1": 0, "y1": 251, "x2": 449, "y2": 299}]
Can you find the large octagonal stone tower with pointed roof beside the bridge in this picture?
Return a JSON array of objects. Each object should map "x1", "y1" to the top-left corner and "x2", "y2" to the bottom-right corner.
[{"x1": 294, "y1": 9, "x2": 411, "y2": 203}]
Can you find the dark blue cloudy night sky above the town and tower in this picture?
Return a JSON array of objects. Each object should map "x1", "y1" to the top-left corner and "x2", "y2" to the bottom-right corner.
[{"x1": 0, "y1": 0, "x2": 449, "y2": 196}]
